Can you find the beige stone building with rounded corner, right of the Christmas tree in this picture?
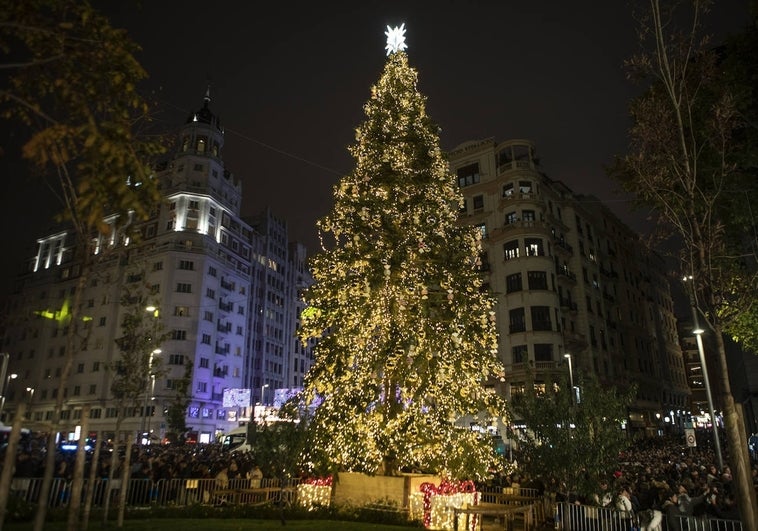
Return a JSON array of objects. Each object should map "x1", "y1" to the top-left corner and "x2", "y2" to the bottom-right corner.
[{"x1": 449, "y1": 139, "x2": 688, "y2": 430}]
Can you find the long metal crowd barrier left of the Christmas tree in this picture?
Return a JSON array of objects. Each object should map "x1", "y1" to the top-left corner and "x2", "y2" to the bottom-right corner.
[{"x1": 10, "y1": 478, "x2": 299, "y2": 507}]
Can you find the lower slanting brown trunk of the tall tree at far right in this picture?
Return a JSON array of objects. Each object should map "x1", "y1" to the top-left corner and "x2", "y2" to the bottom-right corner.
[{"x1": 713, "y1": 326, "x2": 758, "y2": 531}]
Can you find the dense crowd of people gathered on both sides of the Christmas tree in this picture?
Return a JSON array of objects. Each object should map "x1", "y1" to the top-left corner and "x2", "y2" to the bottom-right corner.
[{"x1": 5, "y1": 437, "x2": 758, "y2": 525}]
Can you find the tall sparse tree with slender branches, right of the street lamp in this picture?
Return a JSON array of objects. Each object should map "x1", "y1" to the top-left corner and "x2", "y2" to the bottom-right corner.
[{"x1": 613, "y1": 0, "x2": 758, "y2": 530}]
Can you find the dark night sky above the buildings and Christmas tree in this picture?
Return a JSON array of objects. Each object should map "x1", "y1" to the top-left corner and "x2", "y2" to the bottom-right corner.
[{"x1": 0, "y1": 0, "x2": 748, "y2": 304}]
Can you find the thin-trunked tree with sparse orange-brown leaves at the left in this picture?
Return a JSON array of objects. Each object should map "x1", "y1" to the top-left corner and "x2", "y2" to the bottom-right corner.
[{"x1": 0, "y1": 0, "x2": 166, "y2": 531}]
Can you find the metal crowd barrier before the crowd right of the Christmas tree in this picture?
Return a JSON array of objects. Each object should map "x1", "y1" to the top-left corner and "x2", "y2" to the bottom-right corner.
[{"x1": 555, "y1": 502, "x2": 742, "y2": 531}]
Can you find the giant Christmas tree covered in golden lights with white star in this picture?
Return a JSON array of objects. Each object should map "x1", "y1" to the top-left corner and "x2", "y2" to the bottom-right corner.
[{"x1": 301, "y1": 27, "x2": 504, "y2": 479}]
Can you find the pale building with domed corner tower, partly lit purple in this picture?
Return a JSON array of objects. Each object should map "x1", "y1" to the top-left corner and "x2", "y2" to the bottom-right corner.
[{"x1": 2, "y1": 93, "x2": 310, "y2": 442}]
